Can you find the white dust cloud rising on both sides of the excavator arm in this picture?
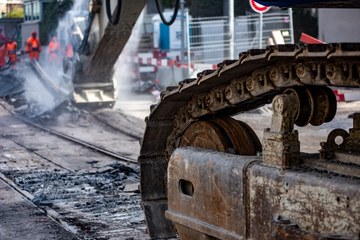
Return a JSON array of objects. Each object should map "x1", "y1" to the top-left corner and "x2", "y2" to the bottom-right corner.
[{"x1": 18, "y1": 0, "x2": 154, "y2": 115}]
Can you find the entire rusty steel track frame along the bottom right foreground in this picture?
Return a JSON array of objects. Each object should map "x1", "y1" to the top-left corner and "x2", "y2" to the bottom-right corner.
[{"x1": 166, "y1": 147, "x2": 360, "y2": 240}]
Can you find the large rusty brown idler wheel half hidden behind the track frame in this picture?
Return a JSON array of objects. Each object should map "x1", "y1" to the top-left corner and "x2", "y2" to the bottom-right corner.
[{"x1": 179, "y1": 117, "x2": 261, "y2": 155}]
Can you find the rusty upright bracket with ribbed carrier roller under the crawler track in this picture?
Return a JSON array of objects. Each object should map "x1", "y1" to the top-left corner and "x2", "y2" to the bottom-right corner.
[{"x1": 263, "y1": 86, "x2": 336, "y2": 169}]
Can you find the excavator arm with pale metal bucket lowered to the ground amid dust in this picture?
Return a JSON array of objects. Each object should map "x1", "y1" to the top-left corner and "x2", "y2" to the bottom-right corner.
[{"x1": 71, "y1": 0, "x2": 147, "y2": 106}]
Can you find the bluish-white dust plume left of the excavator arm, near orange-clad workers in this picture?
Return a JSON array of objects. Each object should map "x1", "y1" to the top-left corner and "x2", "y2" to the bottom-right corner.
[{"x1": 20, "y1": 0, "x2": 89, "y2": 117}]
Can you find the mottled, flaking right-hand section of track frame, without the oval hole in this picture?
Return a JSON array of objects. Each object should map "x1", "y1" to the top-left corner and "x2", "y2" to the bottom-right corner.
[{"x1": 248, "y1": 164, "x2": 360, "y2": 239}]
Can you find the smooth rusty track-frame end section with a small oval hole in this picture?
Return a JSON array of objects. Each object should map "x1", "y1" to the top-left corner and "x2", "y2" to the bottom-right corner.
[{"x1": 166, "y1": 147, "x2": 259, "y2": 239}]
